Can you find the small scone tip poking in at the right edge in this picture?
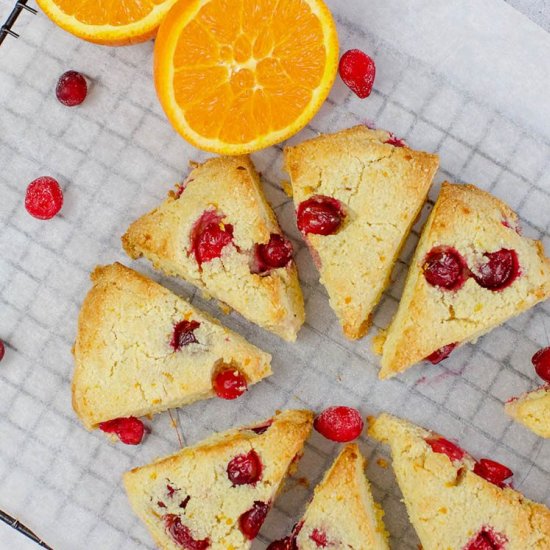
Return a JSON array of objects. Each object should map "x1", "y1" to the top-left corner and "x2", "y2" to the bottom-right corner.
[{"x1": 504, "y1": 386, "x2": 550, "y2": 438}]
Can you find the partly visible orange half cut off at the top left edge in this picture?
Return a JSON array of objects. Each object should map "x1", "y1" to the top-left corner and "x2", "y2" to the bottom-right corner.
[{"x1": 37, "y1": 0, "x2": 176, "y2": 46}]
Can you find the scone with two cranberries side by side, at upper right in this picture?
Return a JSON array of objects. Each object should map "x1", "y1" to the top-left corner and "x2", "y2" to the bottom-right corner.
[{"x1": 377, "y1": 183, "x2": 550, "y2": 378}]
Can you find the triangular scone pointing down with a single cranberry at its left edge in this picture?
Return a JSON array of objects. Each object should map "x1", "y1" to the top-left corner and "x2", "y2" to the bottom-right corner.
[{"x1": 285, "y1": 126, "x2": 438, "y2": 338}]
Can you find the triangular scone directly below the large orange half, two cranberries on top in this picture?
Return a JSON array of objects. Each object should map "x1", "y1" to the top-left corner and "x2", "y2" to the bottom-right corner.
[{"x1": 122, "y1": 156, "x2": 304, "y2": 341}]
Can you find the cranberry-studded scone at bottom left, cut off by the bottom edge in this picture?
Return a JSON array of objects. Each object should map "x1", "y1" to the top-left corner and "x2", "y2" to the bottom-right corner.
[{"x1": 124, "y1": 410, "x2": 313, "y2": 550}]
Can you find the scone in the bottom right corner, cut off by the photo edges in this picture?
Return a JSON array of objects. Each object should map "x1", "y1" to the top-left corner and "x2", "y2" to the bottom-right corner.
[{"x1": 369, "y1": 414, "x2": 550, "y2": 550}]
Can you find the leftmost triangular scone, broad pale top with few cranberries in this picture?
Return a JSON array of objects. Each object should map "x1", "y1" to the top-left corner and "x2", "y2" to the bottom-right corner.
[{"x1": 73, "y1": 263, "x2": 271, "y2": 429}]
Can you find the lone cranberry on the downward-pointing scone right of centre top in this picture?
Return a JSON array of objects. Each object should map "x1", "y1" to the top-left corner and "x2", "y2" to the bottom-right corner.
[{"x1": 297, "y1": 195, "x2": 345, "y2": 235}]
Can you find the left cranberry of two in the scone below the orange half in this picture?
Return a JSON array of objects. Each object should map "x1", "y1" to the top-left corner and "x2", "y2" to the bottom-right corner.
[{"x1": 191, "y1": 210, "x2": 233, "y2": 266}]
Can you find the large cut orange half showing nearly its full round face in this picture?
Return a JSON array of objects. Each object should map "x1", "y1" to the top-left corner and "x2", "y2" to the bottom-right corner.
[{"x1": 155, "y1": 0, "x2": 338, "y2": 155}]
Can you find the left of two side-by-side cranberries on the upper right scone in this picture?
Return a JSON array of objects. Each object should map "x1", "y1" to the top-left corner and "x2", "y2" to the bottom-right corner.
[{"x1": 424, "y1": 246, "x2": 468, "y2": 290}]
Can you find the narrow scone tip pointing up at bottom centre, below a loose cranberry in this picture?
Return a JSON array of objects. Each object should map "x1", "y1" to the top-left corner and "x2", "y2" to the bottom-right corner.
[{"x1": 296, "y1": 443, "x2": 389, "y2": 550}]
